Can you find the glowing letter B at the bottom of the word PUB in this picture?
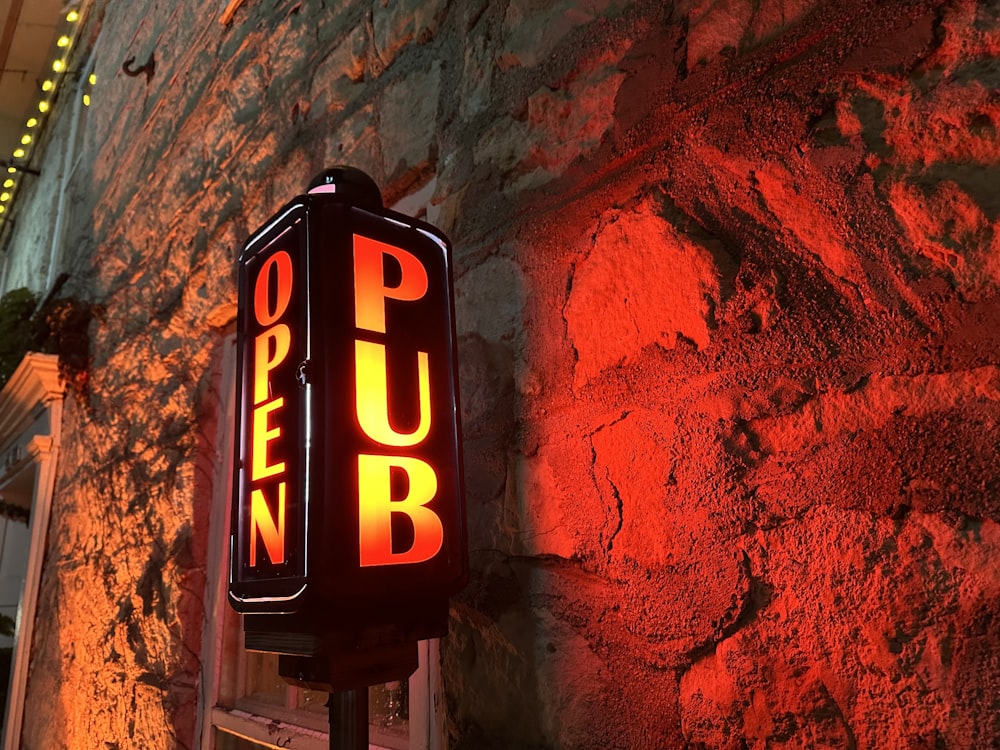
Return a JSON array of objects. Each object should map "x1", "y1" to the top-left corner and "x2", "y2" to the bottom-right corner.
[{"x1": 358, "y1": 453, "x2": 444, "y2": 567}]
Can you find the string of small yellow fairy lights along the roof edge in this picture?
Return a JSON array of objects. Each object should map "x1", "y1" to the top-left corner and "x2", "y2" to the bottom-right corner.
[{"x1": 0, "y1": 8, "x2": 97, "y2": 229}]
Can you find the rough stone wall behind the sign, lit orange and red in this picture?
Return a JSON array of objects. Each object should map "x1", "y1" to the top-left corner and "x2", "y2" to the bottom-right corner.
[{"x1": 7, "y1": 0, "x2": 1000, "y2": 750}]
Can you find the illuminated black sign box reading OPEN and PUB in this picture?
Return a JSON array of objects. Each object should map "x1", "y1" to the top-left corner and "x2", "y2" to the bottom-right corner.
[{"x1": 229, "y1": 168, "x2": 467, "y2": 630}]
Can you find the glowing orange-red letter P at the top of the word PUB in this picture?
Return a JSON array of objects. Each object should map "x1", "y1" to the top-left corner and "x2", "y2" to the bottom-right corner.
[{"x1": 354, "y1": 235, "x2": 427, "y2": 333}]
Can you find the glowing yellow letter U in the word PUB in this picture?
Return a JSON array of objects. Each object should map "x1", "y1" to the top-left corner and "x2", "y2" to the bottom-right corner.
[{"x1": 354, "y1": 341, "x2": 431, "y2": 446}]
